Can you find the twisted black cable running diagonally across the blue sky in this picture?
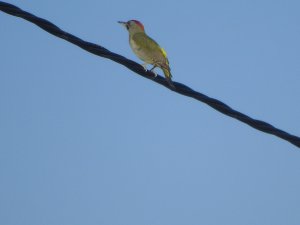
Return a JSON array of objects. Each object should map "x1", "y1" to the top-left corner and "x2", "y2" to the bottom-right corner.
[{"x1": 0, "y1": 1, "x2": 300, "y2": 148}]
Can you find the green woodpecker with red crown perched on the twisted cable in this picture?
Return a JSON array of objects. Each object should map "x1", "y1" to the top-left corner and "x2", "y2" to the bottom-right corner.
[{"x1": 119, "y1": 20, "x2": 175, "y2": 88}]
